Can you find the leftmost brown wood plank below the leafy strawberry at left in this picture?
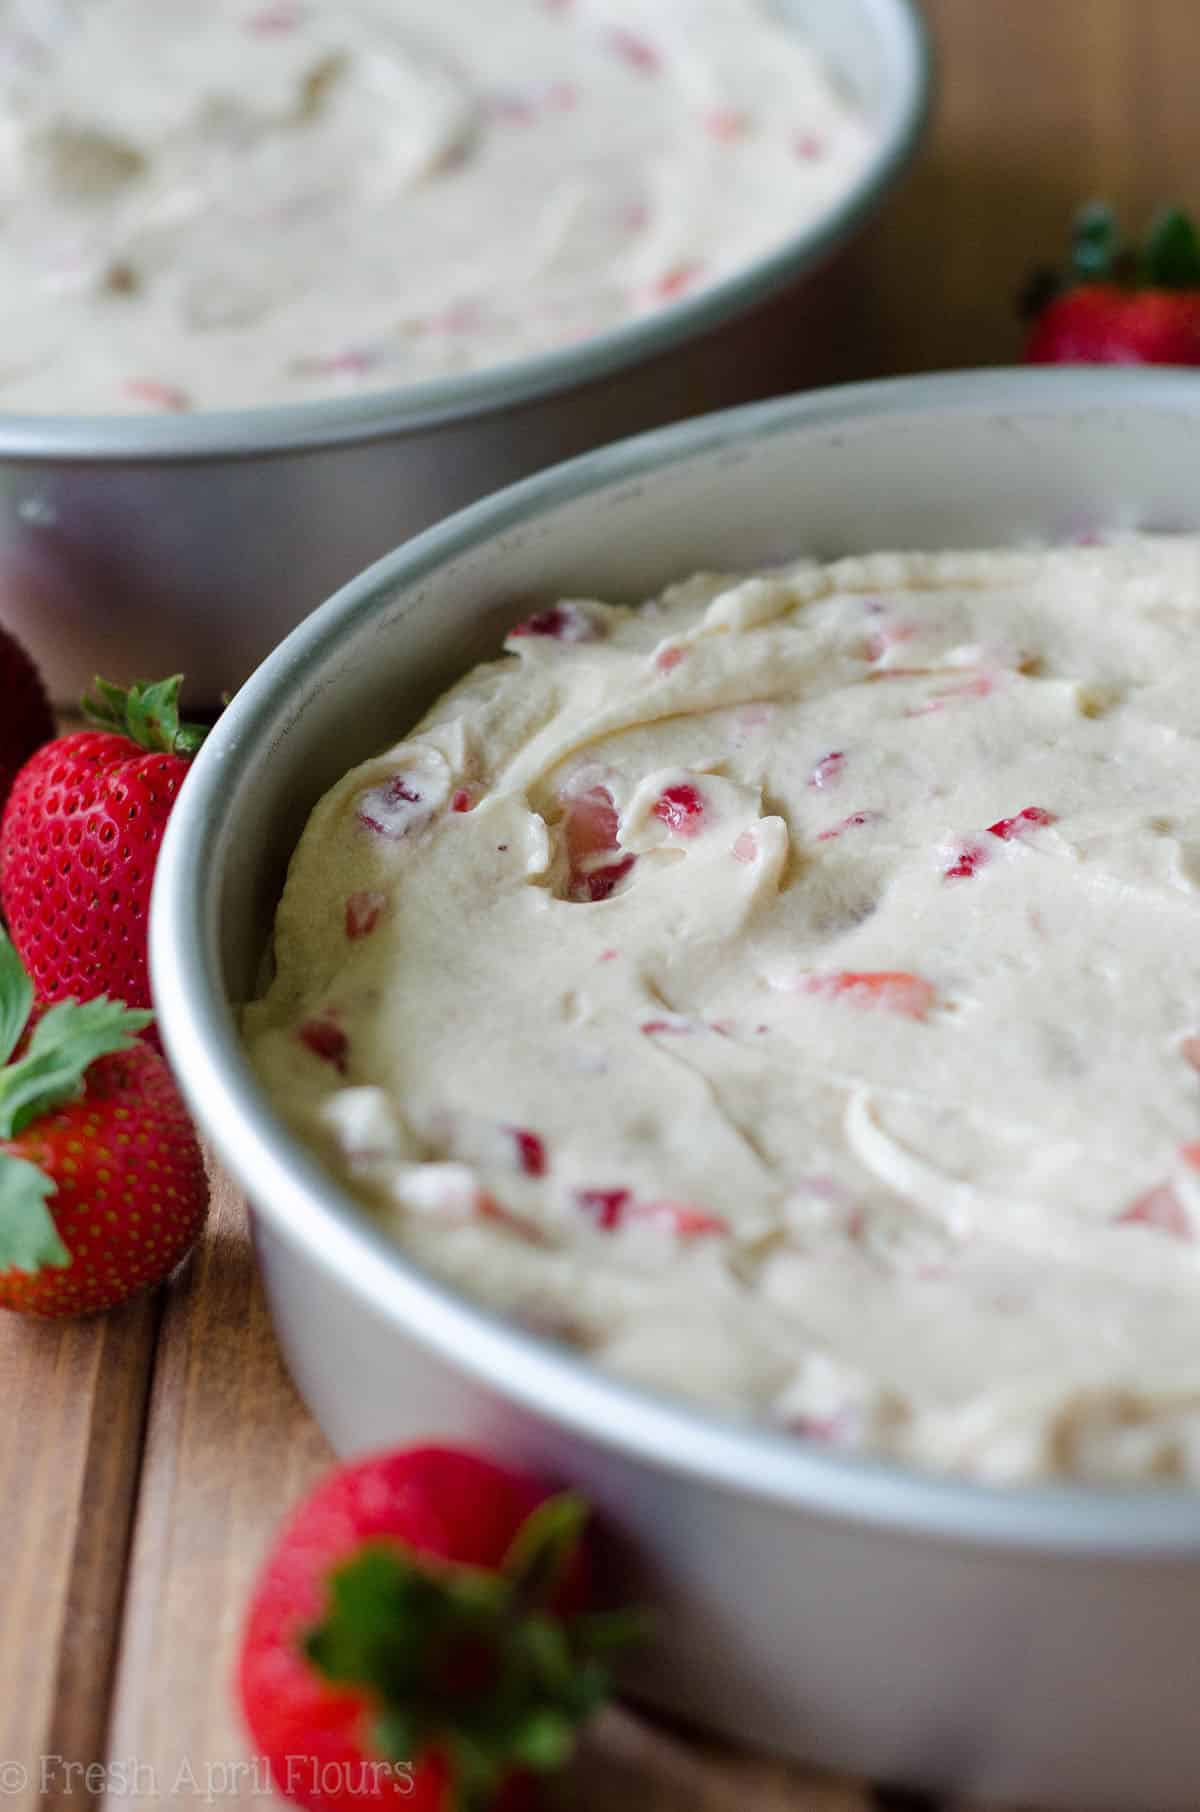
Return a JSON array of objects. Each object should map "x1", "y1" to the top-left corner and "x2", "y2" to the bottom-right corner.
[{"x1": 0, "y1": 1296, "x2": 158, "y2": 1812}]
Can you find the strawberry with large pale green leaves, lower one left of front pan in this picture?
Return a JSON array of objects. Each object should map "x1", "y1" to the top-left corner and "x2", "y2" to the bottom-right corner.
[{"x1": 0, "y1": 931, "x2": 207, "y2": 1317}]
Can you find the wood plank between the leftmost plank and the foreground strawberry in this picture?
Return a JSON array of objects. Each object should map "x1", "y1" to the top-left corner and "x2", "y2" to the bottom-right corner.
[{"x1": 109, "y1": 1176, "x2": 330, "y2": 1808}]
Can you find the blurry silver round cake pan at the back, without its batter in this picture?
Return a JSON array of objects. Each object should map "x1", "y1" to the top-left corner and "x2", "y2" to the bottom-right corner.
[{"x1": 0, "y1": 0, "x2": 928, "y2": 703}]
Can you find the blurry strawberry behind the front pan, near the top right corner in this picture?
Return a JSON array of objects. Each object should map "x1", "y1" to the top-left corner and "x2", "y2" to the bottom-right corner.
[{"x1": 1026, "y1": 203, "x2": 1200, "y2": 364}]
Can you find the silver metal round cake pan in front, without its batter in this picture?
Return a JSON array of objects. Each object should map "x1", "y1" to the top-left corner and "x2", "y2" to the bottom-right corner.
[{"x1": 150, "y1": 370, "x2": 1200, "y2": 1812}]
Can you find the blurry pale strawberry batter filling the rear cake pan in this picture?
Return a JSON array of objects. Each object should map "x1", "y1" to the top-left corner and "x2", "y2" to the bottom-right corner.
[{"x1": 0, "y1": 0, "x2": 872, "y2": 415}]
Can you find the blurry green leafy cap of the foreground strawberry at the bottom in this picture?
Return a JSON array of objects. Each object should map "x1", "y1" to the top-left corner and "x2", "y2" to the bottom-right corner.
[{"x1": 305, "y1": 1493, "x2": 645, "y2": 1812}]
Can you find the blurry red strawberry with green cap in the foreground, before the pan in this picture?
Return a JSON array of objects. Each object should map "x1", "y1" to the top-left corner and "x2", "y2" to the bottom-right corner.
[{"x1": 237, "y1": 1448, "x2": 634, "y2": 1812}]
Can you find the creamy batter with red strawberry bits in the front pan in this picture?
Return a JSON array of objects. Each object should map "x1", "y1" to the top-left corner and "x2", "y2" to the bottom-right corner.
[{"x1": 248, "y1": 536, "x2": 1200, "y2": 1482}]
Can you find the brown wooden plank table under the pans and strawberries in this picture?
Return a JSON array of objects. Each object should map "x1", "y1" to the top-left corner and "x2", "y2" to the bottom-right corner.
[{"x1": 0, "y1": 0, "x2": 1200, "y2": 1812}]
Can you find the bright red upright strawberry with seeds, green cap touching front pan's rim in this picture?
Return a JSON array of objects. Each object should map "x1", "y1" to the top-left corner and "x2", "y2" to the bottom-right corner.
[{"x1": 0, "y1": 674, "x2": 205, "y2": 1007}]
